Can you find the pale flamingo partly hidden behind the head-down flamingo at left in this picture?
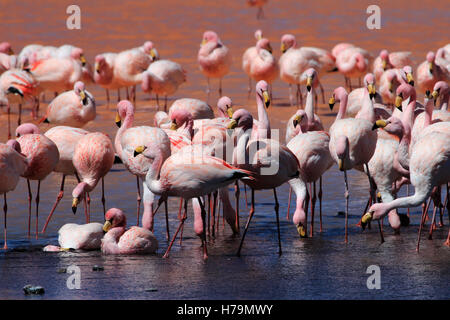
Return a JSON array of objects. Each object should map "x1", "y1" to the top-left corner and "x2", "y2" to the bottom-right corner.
[{"x1": 41, "y1": 126, "x2": 89, "y2": 234}]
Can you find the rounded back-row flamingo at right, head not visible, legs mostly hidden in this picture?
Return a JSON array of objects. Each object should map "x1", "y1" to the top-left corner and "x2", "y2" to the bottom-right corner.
[{"x1": 336, "y1": 47, "x2": 372, "y2": 91}]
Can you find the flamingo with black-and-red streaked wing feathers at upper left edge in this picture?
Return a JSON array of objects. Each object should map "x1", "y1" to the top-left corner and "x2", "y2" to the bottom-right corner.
[{"x1": 0, "y1": 69, "x2": 37, "y2": 139}]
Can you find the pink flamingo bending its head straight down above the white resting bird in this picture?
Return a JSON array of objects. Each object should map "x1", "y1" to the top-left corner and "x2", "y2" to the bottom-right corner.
[{"x1": 72, "y1": 132, "x2": 114, "y2": 223}]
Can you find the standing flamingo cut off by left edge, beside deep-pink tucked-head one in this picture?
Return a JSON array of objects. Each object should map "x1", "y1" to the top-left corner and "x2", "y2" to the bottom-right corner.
[{"x1": 0, "y1": 140, "x2": 28, "y2": 250}]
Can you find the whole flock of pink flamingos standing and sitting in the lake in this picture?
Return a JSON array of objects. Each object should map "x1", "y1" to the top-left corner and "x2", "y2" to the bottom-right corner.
[{"x1": 0, "y1": 14, "x2": 450, "y2": 259}]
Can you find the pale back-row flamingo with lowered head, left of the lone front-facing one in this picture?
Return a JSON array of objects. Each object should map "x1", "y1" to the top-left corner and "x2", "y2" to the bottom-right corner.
[{"x1": 141, "y1": 60, "x2": 186, "y2": 111}]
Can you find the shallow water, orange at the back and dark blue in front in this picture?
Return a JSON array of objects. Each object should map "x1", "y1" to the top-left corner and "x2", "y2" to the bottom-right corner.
[{"x1": 0, "y1": 0, "x2": 450, "y2": 299}]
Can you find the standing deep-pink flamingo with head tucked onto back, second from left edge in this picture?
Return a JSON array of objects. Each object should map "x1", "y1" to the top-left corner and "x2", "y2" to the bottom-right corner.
[{"x1": 16, "y1": 123, "x2": 59, "y2": 239}]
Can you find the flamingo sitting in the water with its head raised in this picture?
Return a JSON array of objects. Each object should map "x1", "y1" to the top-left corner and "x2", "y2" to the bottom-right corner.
[{"x1": 101, "y1": 208, "x2": 158, "y2": 254}]
